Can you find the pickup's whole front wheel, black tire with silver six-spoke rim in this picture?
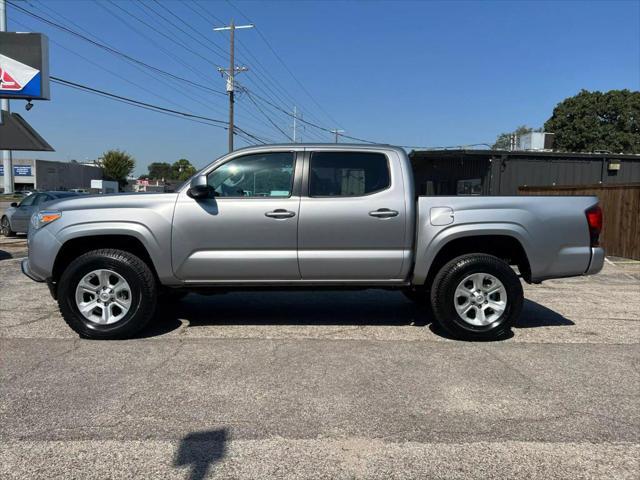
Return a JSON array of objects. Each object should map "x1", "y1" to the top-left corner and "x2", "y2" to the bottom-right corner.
[{"x1": 58, "y1": 249, "x2": 157, "y2": 340}]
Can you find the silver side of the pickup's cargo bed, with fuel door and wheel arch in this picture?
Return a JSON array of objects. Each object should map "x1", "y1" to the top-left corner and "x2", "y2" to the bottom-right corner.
[{"x1": 414, "y1": 196, "x2": 604, "y2": 283}]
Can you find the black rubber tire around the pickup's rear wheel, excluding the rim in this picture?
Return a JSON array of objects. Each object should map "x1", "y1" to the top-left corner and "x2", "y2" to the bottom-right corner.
[{"x1": 431, "y1": 253, "x2": 524, "y2": 340}]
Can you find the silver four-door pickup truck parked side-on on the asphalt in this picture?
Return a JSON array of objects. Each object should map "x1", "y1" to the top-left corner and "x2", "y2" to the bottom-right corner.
[{"x1": 22, "y1": 144, "x2": 604, "y2": 339}]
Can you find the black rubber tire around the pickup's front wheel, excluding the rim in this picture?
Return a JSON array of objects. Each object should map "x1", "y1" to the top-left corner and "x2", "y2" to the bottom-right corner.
[{"x1": 58, "y1": 249, "x2": 157, "y2": 340}]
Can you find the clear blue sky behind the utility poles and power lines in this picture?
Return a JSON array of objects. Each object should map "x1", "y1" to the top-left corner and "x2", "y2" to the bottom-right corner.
[{"x1": 7, "y1": 0, "x2": 640, "y2": 174}]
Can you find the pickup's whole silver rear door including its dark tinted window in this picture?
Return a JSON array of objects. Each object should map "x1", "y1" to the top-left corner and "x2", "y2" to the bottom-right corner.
[{"x1": 298, "y1": 152, "x2": 410, "y2": 281}]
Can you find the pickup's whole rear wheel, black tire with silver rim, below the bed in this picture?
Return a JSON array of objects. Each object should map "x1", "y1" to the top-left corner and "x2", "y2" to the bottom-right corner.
[{"x1": 431, "y1": 253, "x2": 523, "y2": 340}]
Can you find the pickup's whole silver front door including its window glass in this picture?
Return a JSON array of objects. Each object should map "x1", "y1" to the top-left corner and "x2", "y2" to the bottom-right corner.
[{"x1": 172, "y1": 153, "x2": 300, "y2": 283}]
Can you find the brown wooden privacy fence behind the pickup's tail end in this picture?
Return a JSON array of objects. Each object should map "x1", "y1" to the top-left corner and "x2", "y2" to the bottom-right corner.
[{"x1": 518, "y1": 183, "x2": 640, "y2": 260}]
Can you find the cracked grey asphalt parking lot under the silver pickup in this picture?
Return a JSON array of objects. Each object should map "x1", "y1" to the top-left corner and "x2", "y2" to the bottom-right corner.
[{"x1": 0, "y1": 239, "x2": 640, "y2": 479}]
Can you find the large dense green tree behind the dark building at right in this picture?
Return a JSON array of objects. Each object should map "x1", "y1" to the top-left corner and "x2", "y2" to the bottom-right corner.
[{"x1": 544, "y1": 90, "x2": 640, "y2": 153}]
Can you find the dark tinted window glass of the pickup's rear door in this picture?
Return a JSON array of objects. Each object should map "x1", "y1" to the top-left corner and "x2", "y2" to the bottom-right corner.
[{"x1": 309, "y1": 152, "x2": 391, "y2": 197}]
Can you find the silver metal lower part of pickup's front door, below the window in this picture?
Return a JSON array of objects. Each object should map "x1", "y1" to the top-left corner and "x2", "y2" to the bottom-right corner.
[{"x1": 173, "y1": 194, "x2": 300, "y2": 282}]
